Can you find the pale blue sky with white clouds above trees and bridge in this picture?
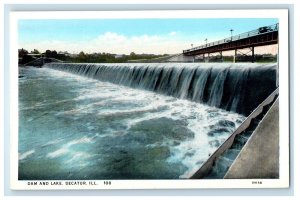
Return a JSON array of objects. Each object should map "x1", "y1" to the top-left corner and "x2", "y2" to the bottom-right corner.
[{"x1": 18, "y1": 18, "x2": 278, "y2": 54}]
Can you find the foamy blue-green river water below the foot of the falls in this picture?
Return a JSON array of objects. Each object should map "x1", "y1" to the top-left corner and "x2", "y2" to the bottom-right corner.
[{"x1": 18, "y1": 67, "x2": 245, "y2": 180}]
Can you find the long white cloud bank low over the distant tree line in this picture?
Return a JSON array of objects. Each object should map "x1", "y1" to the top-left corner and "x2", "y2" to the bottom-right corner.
[{"x1": 19, "y1": 32, "x2": 191, "y2": 54}]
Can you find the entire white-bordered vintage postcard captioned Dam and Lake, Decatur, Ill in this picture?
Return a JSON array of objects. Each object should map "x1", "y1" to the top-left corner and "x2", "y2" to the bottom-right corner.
[{"x1": 9, "y1": 9, "x2": 289, "y2": 190}]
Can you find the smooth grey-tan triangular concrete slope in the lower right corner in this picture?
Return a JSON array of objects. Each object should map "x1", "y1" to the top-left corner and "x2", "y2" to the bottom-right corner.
[{"x1": 224, "y1": 98, "x2": 279, "y2": 179}]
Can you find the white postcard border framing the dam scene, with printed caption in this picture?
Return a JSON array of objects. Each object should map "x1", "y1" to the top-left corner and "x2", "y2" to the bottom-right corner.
[{"x1": 9, "y1": 9, "x2": 289, "y2": 190}]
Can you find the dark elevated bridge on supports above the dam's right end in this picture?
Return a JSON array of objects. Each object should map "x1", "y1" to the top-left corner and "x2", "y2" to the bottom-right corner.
[{"x1": 183, "y1": 23, "x2": 279, "y2": 62}]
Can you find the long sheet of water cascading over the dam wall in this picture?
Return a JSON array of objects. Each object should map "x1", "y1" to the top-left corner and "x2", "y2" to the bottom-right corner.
[{"x1": 44, "y1": 63, "x2": 277, "y2": 115}]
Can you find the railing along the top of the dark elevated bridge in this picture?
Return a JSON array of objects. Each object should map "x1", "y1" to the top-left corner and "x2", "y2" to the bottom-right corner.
[{"x1": 183, "y1": 23, "x2": 279, "y2": 53}]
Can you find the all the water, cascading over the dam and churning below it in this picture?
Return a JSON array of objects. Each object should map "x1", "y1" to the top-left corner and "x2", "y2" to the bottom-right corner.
[{"x1": 19, "y1": 63, "x2": 277, "y2": 180}]
